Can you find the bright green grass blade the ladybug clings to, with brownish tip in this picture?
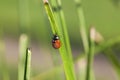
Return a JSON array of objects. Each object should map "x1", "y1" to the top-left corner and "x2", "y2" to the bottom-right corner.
[{"x1": 43, "y1": 0, "x2": 76, "y2": 80}]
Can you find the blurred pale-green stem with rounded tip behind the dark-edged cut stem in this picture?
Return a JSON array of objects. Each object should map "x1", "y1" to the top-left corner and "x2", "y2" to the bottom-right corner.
[{"x1": 18, "y1": 34, "x2": 28, "y2": 80}]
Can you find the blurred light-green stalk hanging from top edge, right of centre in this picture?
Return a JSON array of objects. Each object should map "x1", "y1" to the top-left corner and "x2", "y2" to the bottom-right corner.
[{"x1": 75, "y1": 0, "x2": 89, "y2": 54}]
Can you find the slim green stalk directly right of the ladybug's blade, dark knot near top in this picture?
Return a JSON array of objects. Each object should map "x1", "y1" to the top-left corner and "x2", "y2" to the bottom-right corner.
[{"x1": 54, "y1": 0, "x2": 75, "y2": 78}]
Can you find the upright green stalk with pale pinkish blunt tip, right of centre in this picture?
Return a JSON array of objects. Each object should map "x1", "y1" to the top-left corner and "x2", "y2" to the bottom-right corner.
[{"x1": 86, "y1": 27, "x2": 96, "y2": 80}]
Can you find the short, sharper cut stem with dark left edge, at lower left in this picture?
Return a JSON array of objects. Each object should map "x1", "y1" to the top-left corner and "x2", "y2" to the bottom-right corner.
[{"x1": 24, "y1": 48, "x2": 31, "y2": 80}]
